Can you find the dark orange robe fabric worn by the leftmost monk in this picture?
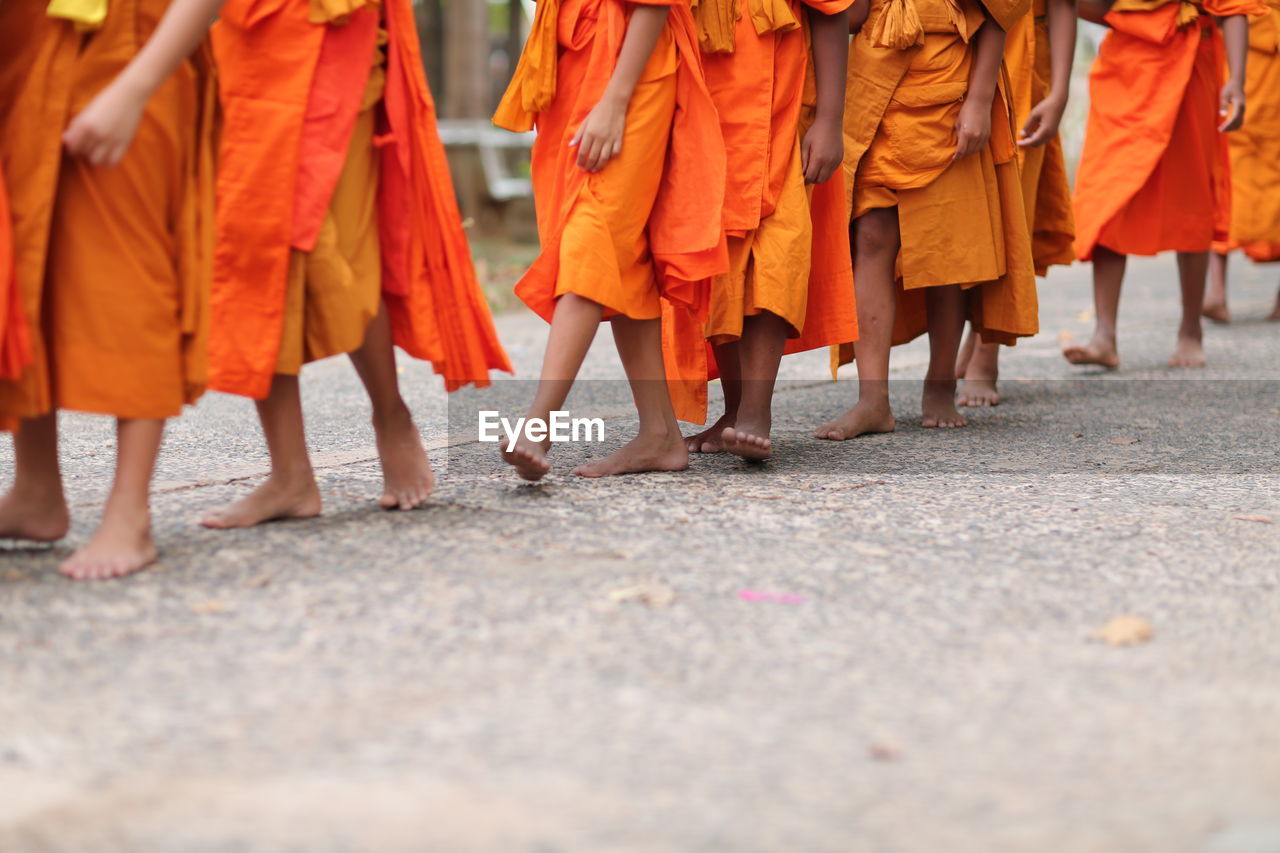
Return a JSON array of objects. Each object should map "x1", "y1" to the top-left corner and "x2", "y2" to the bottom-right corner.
[{"x1": 0, "y1": 0, "x2": 215, "y2": 427}]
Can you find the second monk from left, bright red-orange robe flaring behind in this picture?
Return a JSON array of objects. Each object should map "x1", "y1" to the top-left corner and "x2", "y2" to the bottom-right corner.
[{"x1": 204, "y1": 0, "x2": 511, "y2": 528}]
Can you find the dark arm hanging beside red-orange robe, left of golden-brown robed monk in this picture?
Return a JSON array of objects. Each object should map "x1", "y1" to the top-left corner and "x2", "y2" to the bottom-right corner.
[{"x1": 800, "y1": 8, "x2": 849, "y2": 183}]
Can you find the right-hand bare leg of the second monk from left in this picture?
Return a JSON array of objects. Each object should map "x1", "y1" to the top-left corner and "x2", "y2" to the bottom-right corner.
[{"x1": 351, "y1": 304, "x2": 435, "y2": 510}]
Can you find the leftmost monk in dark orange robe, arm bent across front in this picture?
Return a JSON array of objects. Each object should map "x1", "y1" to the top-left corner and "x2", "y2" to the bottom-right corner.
[{"x1": 0, "y1": 0, "x2": 219, "y2": 579}]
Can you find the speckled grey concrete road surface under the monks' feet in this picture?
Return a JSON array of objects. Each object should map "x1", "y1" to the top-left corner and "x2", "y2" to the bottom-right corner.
[{"x1": 0, "y1": 260, "x2": 1280, "y2": 853}]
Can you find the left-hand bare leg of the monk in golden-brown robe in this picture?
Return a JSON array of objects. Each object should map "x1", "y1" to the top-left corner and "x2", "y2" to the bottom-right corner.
[{"x1": 813, "y1": 207, "x2": 901, "y2": 441}]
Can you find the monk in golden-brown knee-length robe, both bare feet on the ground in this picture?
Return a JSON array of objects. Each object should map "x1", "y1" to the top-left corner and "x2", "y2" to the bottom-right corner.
[{"x1": 814, "y1": 0, "x2": 1038, "y2": 439}]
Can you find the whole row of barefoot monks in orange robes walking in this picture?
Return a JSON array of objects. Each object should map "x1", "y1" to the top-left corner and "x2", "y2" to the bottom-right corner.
[{"x1": 0, "y1": 0, "x2": 1280, "y2": 579}]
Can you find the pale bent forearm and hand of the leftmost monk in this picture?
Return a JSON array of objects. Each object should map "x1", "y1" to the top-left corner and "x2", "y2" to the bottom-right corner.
[{"x1": 63, "y1": 0, "x2": 223, "y2": 167}]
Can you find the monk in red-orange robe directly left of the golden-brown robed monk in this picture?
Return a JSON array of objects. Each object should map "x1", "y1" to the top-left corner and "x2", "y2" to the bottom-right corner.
[{"x1": 687, "y1": 0, "x2": 856, "y2": 460}]
